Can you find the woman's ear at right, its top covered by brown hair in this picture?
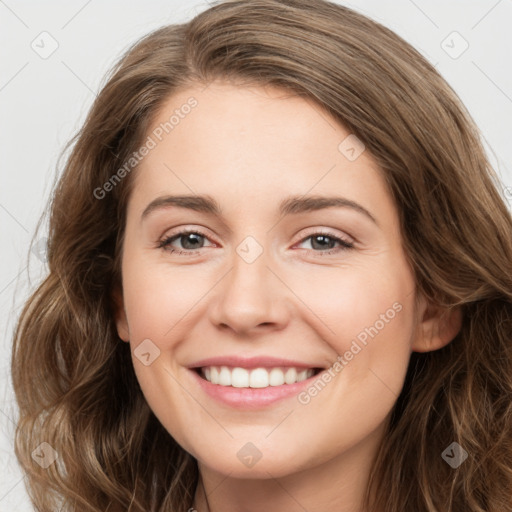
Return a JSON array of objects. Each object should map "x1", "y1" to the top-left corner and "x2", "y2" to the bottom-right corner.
[{"x1": 411, "y1": 298, "x2": 462, "y2": 352}]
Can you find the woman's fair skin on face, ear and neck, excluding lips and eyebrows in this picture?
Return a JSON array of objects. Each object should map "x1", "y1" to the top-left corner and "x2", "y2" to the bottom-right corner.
[{"x1": 115, "y1": 81, "x2": 460, "y2": 512}]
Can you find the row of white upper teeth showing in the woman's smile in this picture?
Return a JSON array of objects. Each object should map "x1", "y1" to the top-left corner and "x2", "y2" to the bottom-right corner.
[{"x1": 201, "y1": 366, "x2": 315, "y2": 388}]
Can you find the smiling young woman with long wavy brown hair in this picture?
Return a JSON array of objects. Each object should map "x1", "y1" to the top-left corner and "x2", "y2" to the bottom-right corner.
[{"x1": 12, "y1": 0, "x2": 512, "y2": 512}]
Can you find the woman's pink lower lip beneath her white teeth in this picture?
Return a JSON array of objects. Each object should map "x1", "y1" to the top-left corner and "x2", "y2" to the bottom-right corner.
[{"x1": 189, "y1": 370, "x2": 320, "y2": 409}]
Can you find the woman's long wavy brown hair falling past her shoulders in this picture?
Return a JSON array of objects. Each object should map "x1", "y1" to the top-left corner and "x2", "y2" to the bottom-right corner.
[{"x1": 12, "y1": 0, "x2": 512, "y2": 512}]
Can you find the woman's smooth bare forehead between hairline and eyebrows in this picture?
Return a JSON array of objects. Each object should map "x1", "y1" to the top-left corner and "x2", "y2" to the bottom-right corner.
[{"x1": 127, "y1": 82, "x2": 393, "y2": 228}]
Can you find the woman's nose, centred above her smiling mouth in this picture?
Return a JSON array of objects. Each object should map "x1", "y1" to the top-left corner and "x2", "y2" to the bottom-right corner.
[{"x1": 206, "y1": 240, "x2": 292, "y2": 336}]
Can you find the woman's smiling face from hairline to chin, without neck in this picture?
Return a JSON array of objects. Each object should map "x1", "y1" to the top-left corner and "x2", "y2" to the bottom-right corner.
[{"x1": 112, "y1": 82, "x2": 444, "y2": 478}]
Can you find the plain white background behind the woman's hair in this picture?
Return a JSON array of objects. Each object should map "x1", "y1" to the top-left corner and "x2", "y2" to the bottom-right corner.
[{"x1": 0, "y1": 0, "x2": 512, "y2": 512}]
